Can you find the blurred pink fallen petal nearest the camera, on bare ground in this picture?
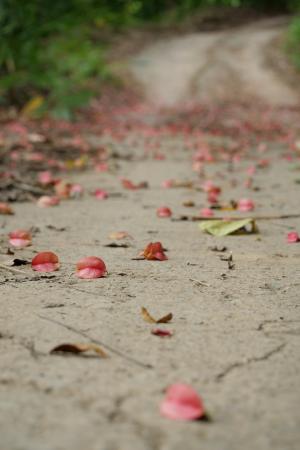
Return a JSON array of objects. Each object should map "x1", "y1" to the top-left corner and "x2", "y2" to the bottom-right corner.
[{"x1": 160, "y1": 383, "x2": 205, "y2": 420}]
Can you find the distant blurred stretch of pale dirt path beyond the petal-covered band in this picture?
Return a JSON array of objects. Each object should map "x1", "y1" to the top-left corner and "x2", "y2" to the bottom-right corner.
[{"x1": 131, "y1": 18, "x2": 300, "y2": 106}]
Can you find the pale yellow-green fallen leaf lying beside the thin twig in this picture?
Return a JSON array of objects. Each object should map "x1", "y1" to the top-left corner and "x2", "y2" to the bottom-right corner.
[{"x1": 199, "y1": 218, "x2": 258, "y2": 236}]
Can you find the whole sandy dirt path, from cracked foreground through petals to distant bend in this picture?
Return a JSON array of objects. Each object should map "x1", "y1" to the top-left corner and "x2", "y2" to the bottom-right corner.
[{"x1": 0, "y1": 15, "x2": 300, "y2": 450}]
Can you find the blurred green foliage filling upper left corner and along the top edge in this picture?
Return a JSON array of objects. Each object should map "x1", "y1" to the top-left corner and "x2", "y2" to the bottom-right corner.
[{"x1": 0, "y1": 0, "x2": 300, "y2": 117}]
